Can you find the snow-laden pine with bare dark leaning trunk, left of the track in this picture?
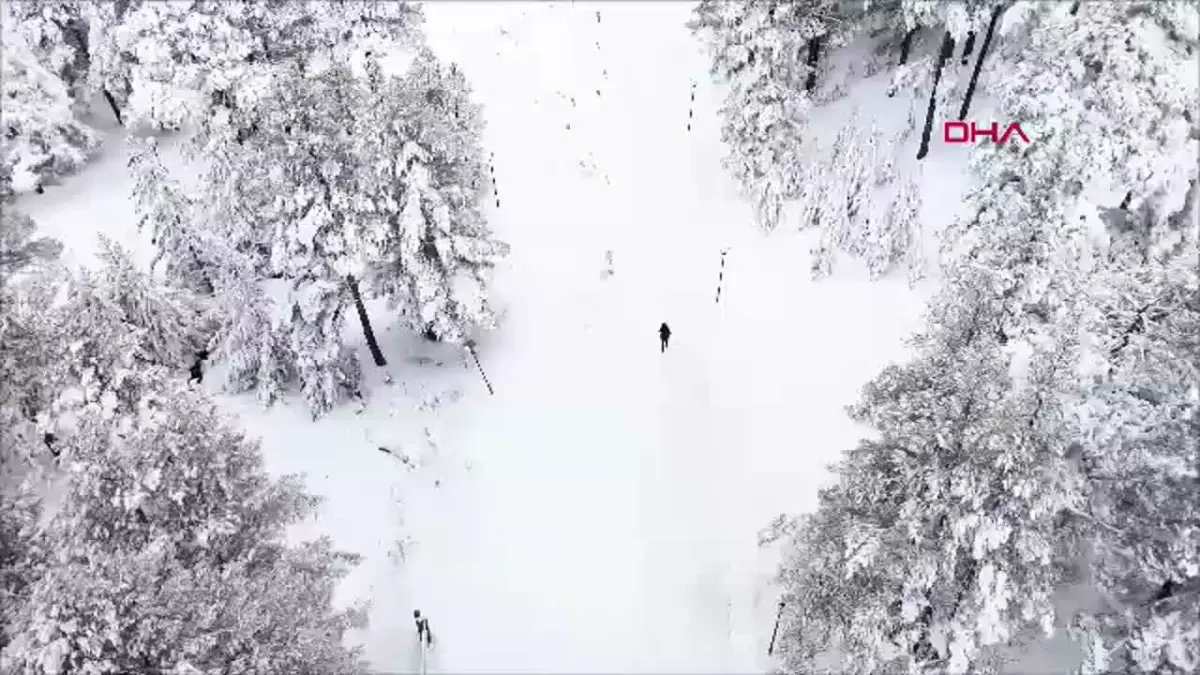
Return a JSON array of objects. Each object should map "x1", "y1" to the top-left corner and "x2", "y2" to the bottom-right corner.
[{"x1": 195, "y1": 43, "x2": 506, "y2": 411}]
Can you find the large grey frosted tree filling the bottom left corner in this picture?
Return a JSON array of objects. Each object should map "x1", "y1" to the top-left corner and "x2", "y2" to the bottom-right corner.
[{"x1": 2, "y1": 386, "x2": 366, "y2": 675}]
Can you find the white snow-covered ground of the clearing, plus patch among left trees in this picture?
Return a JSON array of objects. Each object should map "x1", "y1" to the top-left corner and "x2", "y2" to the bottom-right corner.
[{"x1": 14, "y1": 2, "x2": 940, "y2": 673}]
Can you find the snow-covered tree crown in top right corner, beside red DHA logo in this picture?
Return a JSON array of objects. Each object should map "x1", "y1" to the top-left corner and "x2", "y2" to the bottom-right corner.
[{"x1": 990, "y1": 2, "x2": 1200, "y2": 207}]
